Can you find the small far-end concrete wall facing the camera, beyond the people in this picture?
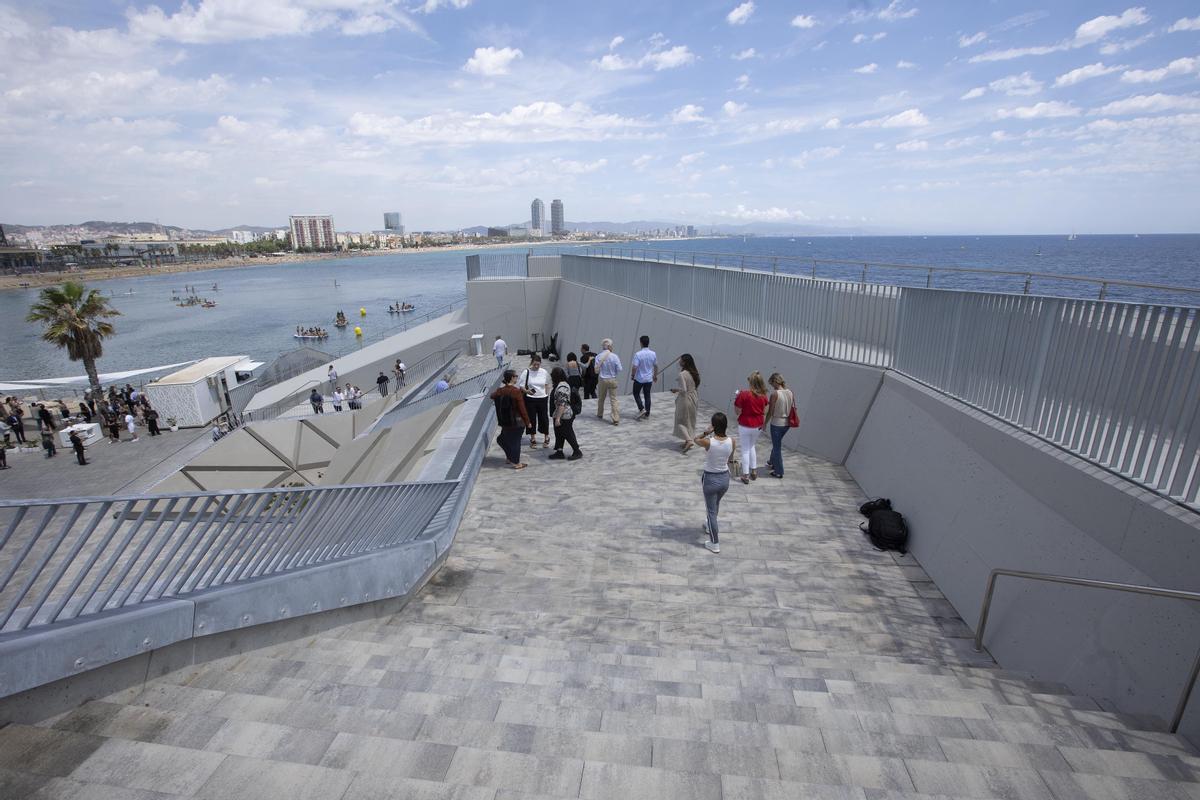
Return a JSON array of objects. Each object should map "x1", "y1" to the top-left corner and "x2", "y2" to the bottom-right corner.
[{"x1": 467, "y1": 278, "x2": 565, "y2": 355}]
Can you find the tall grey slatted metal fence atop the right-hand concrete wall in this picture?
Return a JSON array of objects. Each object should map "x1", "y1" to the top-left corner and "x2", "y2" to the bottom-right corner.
[{"x1": 563, "y1": 254, "x2": 1200, "y2": 510}]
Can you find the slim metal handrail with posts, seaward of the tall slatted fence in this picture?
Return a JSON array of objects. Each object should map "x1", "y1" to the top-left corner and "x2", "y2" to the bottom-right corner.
[{"x1": 584, "y1": 247, "x2": 1200, "y2": 300}]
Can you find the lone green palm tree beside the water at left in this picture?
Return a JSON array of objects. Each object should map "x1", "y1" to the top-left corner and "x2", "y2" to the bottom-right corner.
[{"x1": 25, "y1": 281, "x2": 121, "y2": 393}]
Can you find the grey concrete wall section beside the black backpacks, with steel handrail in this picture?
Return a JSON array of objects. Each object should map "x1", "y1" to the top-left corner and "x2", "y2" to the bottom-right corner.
[{"x1": 846, "y1": 373, "x2": 1200, "y2": 736}]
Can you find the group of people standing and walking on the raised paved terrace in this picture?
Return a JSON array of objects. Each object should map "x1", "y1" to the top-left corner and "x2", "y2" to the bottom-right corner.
[{"x1": 491, "y1": 336, "x2": 799, "y2": 553}]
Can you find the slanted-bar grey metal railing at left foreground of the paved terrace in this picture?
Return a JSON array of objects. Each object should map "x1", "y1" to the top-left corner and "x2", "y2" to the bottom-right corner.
[{"x1": 0, "y1": 481, "x2": 457, "y2": 632}]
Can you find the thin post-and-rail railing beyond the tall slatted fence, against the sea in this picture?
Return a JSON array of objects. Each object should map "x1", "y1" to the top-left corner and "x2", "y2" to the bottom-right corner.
[{"x1": 581, "y1": 246, "x2": 1200, "y2": 302}]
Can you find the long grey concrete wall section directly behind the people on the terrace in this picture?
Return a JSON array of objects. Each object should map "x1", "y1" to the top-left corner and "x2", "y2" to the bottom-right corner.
[{"x1": 553, "y1": 282, "x2": 882, "y2": 464}]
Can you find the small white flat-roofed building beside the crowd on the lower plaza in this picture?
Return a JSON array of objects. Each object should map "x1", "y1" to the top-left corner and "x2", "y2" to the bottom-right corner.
[{"x1": 146, "y1": 355, "x2": 263, "y2": 428}]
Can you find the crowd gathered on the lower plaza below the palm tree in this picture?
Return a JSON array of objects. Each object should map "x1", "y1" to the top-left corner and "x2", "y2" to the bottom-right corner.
[{"x1": 0, "y1": 384, "x2": 170, "y2": 469}]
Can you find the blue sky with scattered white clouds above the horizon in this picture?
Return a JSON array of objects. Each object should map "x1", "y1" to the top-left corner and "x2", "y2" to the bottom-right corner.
[{"x1": 0, "y1": 0, "x2": 1200, "y2": 234}]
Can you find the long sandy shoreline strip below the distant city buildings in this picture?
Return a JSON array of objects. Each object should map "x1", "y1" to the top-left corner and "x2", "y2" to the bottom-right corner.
[{"x1": 0, "y1": 239, "x2": 624, "y2": 291}]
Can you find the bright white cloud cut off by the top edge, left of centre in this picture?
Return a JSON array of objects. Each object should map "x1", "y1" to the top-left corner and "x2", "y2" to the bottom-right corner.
[{"x1": 126, "y1": 0, "x2": 421, "y2": 44}]
